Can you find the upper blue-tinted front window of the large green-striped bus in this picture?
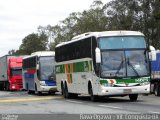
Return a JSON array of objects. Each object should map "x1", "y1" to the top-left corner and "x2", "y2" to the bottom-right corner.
[{"x1": 99, "y1": 36, "x2": 146, "y2": 49}]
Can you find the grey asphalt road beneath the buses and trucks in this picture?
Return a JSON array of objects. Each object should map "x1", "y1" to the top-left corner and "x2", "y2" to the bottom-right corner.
[{"x1": 0, "y1": 91, "x2": 160, "y2": 120}]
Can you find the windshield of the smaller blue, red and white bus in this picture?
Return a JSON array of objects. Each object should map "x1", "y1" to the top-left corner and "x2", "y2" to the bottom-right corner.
[{"x1": 39, "y1": 57, "x2": 55, "y2": 81}]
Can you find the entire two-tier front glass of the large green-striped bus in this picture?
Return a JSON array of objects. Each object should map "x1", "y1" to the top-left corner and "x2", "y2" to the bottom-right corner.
[{"x1": 99, "y1": 36, "x2": 149, "y2": 78}]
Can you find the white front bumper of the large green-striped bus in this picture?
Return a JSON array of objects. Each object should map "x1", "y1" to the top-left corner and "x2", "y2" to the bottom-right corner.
[{"x1": 98, "y1": 84, "x2": 150, "y2": 96}]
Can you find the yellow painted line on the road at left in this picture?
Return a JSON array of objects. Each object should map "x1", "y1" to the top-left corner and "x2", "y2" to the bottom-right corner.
[{"x1": 0, "y1": 97, "x2": 62, "y2": 103}]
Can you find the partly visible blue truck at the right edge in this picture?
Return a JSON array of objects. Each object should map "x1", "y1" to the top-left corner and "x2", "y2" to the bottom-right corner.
[{"x1": 150, "y1": 50, "x2": 160, "y2": 96}]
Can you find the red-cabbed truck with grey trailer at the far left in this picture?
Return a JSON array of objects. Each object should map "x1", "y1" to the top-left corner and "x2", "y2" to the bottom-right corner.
[{"x1": 0, "y1": 55, "x2": 23, "y2": 91}]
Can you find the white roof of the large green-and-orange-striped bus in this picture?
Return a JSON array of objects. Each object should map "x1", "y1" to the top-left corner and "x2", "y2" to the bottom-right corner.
[{"x1": 56, "y1": 30, "x2": 144, "y2": 47}]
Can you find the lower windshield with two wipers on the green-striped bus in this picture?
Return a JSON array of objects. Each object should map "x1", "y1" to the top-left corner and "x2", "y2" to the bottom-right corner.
[{"x1": 101, "y1": 50, "x2": 149, "y2": 77}]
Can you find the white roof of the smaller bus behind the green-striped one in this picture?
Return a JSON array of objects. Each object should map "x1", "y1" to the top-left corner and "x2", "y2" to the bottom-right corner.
[{"x1": 24, "y1": 51, "x2": 55, "y2": 59}]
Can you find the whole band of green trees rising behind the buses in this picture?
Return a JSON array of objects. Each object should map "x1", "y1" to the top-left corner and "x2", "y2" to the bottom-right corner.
[{"x1": 10, "y1": 0, "x2": 160, "y2": 54}]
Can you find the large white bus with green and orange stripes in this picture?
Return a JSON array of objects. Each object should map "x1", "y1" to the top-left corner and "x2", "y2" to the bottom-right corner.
[{"x1": 55, "y1": 30, "x2": 150, "y2": 101}]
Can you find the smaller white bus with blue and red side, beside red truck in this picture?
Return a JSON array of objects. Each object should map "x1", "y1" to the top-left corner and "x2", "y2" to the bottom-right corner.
[{"x1": 22, "y1": 51, "x2": 57, "y2": 95}]
